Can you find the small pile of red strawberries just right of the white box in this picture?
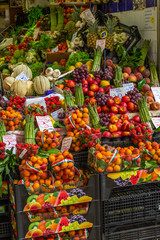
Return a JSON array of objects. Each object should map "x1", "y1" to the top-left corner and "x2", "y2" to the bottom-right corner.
[{"x1": 45, "y1": 96, "x2": 61, "y2": 114}]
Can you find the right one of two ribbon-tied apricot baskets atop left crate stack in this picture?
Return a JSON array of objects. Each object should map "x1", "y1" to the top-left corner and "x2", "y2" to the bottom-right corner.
[{"x1": 49, "y1": 151, "x2": 75, "y2": 187}]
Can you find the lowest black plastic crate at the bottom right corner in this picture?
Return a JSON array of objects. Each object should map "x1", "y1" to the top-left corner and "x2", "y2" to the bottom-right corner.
[{"x1": 102, "y1": 221, "x2": 160, "y2": 240}]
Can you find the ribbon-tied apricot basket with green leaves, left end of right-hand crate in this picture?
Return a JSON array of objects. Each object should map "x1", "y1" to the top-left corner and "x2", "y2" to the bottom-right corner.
[{"x1": 89, "y1": 144, "x2": 122, "y2": 172}]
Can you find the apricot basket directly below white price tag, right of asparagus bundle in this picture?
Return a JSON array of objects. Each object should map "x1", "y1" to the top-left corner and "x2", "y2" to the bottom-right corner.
[{"x1": 36, "y1": 130, "x2": 62, "y2": 151}]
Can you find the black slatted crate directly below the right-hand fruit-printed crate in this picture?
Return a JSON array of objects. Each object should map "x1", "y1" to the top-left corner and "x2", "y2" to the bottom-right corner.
[{"x1": 102, "y1": 182, "x2": 160, "y2": 233}]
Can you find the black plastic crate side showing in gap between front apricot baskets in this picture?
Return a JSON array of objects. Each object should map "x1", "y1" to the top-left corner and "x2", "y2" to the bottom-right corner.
[{"x1": 72, "y1": 150, "x2": 88, "y2": 168}]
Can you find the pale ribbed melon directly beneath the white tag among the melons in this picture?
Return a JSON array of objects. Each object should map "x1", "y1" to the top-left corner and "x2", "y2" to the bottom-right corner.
[{"x1": 11, "y1": 80, "x2": 27, "y2": 97}]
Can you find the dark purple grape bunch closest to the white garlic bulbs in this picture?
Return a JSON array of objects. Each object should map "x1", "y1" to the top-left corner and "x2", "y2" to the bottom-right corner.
[{"x1": 71, "y1": 65, "x2": 89, "y2": 83}]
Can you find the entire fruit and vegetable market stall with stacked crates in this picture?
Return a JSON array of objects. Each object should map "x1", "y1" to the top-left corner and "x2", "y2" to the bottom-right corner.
[{"x1": 0, "y1": 3, "x2": 160, "y2": 240}]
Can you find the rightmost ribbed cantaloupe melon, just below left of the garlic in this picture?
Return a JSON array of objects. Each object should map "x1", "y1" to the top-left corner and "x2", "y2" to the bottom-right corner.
[{"x1": 33, "y1": 76, "x2": 50, "y2": 95}]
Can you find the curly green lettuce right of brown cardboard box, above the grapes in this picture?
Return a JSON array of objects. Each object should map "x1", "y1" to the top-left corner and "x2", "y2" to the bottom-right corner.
[{"x1": 66, "y1": 52, "x2": 89, "y2": 71}]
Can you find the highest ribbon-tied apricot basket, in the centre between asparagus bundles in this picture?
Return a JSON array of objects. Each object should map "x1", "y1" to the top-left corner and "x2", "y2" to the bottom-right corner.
[{"x1": 64, "y1": 107, "x2": 89, "y2": 131}]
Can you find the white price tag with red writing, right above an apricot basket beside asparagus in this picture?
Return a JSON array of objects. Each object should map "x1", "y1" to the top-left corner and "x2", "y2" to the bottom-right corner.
[{"x1": 36, "y1": 116, "x2": 54, "y2": 132}]
